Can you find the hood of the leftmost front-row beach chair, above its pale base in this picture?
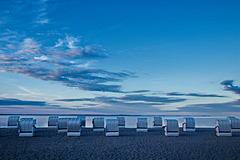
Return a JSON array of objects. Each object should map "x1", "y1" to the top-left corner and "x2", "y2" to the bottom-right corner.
[{"x1": 20, "y1": 118, "x2": 36, "y2": 133}]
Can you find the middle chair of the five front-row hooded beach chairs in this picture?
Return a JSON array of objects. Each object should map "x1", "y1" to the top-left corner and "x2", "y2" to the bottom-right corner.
[{"x1": 106, "y1": 119, "x2": 119, "y2": 137}]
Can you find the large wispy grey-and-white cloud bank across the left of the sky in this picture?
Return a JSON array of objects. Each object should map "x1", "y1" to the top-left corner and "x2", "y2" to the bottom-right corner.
[{"x1": 0, "y1": 37, "x2": 132, "y2": 93}]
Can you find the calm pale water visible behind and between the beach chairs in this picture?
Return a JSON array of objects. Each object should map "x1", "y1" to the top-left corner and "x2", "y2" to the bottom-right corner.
[{"x1": 0, "y1": 115, "x2": 240, "y2": 128}]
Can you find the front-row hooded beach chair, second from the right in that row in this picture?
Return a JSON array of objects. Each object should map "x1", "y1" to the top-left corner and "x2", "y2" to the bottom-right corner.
[{"x1": 164, "y1": 119, "x2": 179, "y2": 137}]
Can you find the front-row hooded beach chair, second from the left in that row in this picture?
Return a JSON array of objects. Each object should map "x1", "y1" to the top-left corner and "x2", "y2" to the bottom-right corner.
[{"x1": 67, "y1": 118, "x2": 82, "y2": 136}]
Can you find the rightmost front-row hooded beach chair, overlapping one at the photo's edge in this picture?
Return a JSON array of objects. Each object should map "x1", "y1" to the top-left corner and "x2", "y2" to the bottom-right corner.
[{"x1": 215, "y1": 120, "x2": 232, "y2": 136}]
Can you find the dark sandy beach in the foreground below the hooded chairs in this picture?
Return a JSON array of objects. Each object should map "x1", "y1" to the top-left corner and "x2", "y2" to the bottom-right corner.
[{"x1": 0, "y1": 129, "x2": 240, "y2": 160}]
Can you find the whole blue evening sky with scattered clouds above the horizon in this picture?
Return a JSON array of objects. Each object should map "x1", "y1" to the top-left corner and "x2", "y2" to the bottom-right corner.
[{"x1": 0, "y1": 0, "x2": 240, "y2": 115}]
